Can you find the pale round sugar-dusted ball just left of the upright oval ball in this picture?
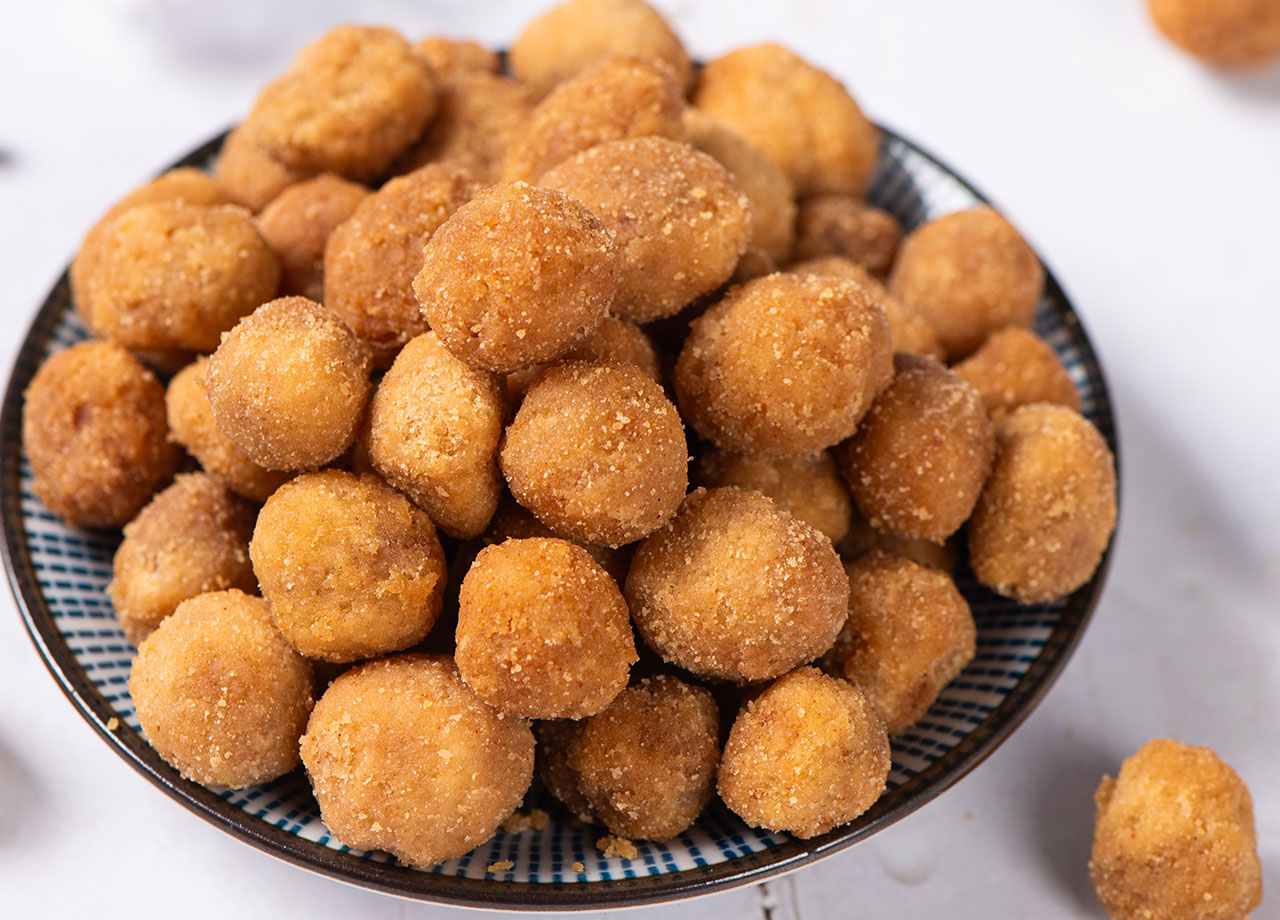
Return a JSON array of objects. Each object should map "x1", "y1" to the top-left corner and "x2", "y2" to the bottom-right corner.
[{"x1": 205, "y1": 297, "x2": 369, "y2": 470}]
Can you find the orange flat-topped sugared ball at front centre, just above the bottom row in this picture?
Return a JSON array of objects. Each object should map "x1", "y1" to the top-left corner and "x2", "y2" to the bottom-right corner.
[{"x1": 454, "y1": 537, "x2": 636, "y2": 719}]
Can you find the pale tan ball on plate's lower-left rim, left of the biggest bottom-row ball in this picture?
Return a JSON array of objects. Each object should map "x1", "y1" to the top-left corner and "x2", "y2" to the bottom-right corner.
[{"x1": 129, "y1": 589, "x2": 312, "y2": 788}]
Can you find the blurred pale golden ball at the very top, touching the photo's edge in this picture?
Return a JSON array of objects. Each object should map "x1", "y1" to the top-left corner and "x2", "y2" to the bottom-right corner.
[{"x1": 508, "y1": 0, "x2": 692, "y2": 96}]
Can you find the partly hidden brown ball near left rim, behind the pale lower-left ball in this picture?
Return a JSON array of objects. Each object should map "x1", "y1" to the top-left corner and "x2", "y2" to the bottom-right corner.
[{"x1": 108, "y1": 473, "x2": 257, "y2": 645}]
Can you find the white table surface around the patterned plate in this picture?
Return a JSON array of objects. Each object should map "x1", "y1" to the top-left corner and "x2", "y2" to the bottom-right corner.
[{"x1": 0, "y1": 0, "x2": 1280, "y2": 920}]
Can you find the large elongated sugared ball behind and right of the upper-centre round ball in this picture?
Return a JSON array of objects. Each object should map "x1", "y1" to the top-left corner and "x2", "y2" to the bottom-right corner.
[{"x1": 541, "y1": 137, "x2": 751, "y2": 322}]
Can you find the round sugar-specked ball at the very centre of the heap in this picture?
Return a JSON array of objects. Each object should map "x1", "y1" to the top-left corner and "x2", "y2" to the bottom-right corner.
[{"x1": 499, "y1": 363, "x2": 689, "y2": 546}]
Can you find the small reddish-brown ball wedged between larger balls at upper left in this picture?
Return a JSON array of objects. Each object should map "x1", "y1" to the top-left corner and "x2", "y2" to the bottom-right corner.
[{"x1": 257, "y1": 174, "x2": 369, "y2": 303}]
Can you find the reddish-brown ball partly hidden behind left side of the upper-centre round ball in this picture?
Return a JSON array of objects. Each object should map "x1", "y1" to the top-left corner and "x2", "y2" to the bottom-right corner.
[{"x1": 324, "y1": 165, "x2": 477, "y2": 367}]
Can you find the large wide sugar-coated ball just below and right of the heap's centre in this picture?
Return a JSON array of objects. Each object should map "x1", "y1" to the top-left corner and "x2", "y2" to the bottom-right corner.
[{"x1": 626, "y1": 486, "x2": 849, "y2": 683}]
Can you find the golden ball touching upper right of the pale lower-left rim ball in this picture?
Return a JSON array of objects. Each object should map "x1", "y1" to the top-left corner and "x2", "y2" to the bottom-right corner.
[{"x1": 248, "y1": 470, "x2": 445, "y2": 662}]
